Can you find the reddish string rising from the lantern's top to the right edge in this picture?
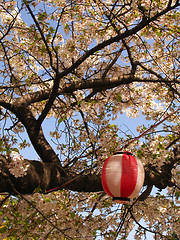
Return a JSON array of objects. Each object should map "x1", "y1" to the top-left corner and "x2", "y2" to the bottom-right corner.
[{"x1": 118, "y1": 107, "x2": 180, "y2": 151}]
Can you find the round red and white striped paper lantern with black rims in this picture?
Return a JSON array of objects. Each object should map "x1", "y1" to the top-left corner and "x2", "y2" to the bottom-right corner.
[{"x1": 101, "y1": 151, "x2": 145, "y2": 203}]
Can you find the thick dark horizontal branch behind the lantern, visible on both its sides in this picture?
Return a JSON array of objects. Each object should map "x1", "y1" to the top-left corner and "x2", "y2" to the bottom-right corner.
[{"x1": 0, "y1": 144, "x2": 180, "y2": 194}]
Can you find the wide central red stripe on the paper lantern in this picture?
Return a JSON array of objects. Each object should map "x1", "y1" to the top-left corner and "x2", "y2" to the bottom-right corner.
[{"x1": 121, "y1": 154, "x2": 138, "y2": 198}]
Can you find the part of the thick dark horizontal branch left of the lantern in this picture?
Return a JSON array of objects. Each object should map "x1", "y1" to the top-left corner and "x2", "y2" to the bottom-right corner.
[{"x1": 0, "y1": 156, "x2": 103, "y2": 194}]
